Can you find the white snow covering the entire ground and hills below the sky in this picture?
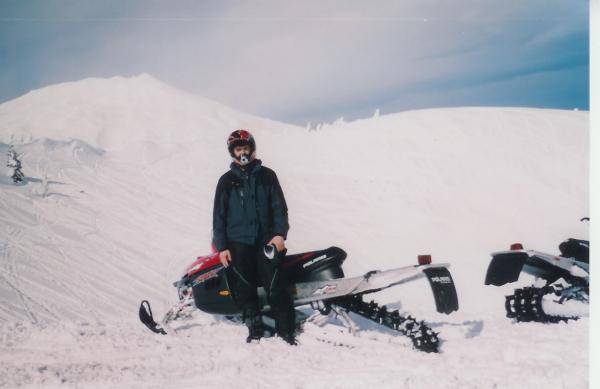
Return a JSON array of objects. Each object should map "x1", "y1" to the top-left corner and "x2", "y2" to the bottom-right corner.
[{"x1": 0, "y1": 75, "x2": 589, "y2": 388}]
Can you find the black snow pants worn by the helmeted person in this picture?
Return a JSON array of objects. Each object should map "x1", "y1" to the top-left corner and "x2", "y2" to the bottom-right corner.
[{"x1": 227, "y1": 242, "x2": 295, "y2": 336}]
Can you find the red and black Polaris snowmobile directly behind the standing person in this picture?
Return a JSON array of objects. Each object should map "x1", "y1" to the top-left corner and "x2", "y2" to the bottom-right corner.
[{"x1": 139, "y1": 246, "x2": 458, "y2": 352}]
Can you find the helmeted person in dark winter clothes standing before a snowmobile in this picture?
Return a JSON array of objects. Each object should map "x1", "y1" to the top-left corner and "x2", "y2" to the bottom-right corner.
[{"x1": 213, "y1": 130, "x2": 296, "y2": 345}]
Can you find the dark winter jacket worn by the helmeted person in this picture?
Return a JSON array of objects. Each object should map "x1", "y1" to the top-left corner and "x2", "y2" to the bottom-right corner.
[{"x1": 213, "y1": 160, "x2": 290, "y2": 251}]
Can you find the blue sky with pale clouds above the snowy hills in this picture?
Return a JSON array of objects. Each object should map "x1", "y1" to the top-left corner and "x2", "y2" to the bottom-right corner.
[{"x1": 0, "y1": 0, "x2": 589, "y2": 125}]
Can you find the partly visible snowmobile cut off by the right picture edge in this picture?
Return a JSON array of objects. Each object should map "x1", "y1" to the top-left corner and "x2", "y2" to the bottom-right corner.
[{"x1": 485, "y1": 233, "x2": 590, "y2": 323}]
